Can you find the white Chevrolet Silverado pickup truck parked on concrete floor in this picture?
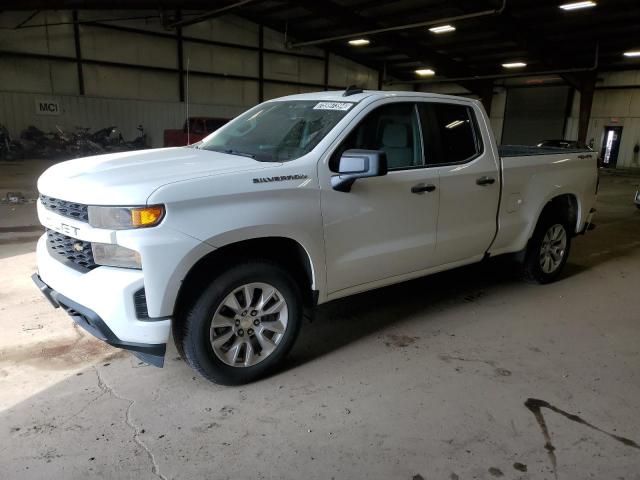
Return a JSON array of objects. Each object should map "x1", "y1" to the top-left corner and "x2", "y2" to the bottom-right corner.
[{"x1": 33, "y1": 89, "x2": 597, "y2": 384}]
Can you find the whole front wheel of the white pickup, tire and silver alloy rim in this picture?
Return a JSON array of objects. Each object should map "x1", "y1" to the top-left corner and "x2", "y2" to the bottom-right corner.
[{"x1": 182, "y1": 261, "x2": 303, "y2": 385}]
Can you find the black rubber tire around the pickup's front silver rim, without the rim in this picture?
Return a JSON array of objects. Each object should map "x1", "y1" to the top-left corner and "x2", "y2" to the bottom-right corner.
[{"x1": 181, "y1": 260, "x2": 303, "y2": 385}]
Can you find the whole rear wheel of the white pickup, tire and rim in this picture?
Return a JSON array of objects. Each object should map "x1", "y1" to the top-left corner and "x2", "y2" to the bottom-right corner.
[{"x1": 524, "y1": 217, "x2": 571, "y2": 283}]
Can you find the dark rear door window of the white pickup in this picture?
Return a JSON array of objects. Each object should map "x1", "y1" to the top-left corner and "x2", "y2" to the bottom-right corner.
[{"x1": 420, "y1": 103, "x2": 482, "y2": 164}]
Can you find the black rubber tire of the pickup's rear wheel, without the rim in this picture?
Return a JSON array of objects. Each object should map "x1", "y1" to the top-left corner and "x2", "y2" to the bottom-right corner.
[{"x1": 523, "y1": 214, "x2": 572, "y2": 284}]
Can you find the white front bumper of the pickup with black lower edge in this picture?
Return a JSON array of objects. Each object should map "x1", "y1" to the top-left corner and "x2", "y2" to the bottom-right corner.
[{"x1": 34, "y1": 235, "x2": 171, "y2": 366}]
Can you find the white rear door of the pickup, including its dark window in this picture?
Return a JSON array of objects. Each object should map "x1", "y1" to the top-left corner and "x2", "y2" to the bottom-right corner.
[{"x1": 420, "y1": 101, "x2": 500, "y2": 265}]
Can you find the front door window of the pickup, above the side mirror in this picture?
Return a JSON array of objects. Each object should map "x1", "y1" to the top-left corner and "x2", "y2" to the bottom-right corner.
[{"x1": 329, "y1": 103, "x2": 424, "y2": 171}]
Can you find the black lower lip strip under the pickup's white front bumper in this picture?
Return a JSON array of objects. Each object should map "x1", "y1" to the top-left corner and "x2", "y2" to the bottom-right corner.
[{"x1": 31, "y1": 273, "x2": 167, "y2": 367}]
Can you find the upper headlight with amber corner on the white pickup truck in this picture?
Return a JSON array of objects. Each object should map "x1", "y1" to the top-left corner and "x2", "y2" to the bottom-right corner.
[{"x1": 89, "y1": 205, "x2": 164, "y2": 230}]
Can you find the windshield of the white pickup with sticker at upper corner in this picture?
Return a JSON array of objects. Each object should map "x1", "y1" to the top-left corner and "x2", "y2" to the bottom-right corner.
[{"x1": 199, "y1": 100, "x2": 354, "y2": 162}]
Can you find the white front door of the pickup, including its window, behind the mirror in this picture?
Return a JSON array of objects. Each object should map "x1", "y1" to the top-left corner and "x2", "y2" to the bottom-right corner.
[{"x1": 320, "y1": 99, "x2": 439, "y2": 296}]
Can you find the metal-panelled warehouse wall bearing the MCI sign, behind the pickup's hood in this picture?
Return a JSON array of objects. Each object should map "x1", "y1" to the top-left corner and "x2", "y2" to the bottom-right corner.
[{"x1": 0, "y1": 11, "x2": 378, "y2": 147}]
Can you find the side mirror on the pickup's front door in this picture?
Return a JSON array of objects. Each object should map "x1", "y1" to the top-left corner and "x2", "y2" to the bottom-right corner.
[{"x1": 331, "y1": 150, "x2": 387, "y2": 192}]
